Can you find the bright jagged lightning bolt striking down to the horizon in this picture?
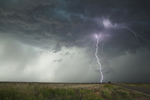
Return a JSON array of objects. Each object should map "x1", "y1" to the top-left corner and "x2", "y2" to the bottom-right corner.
[{"x1": 95, "y1": 34, "x2": 103, "y2": 83}]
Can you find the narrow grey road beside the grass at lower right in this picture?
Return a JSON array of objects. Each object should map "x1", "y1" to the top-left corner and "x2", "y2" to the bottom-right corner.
[{"x1": 114, "y1": 84, "x2": 150, "y2": 96}]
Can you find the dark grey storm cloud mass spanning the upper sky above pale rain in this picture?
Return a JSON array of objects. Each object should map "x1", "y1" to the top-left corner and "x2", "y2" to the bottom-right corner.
[{"x1": 0, "y1": 0, "x2": 150, "y2": 83}]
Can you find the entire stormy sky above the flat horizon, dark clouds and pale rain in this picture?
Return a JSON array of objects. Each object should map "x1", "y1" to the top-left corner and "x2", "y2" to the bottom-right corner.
[{"x1": 0, "y1": 0, "x2": 150, "y2": 83}]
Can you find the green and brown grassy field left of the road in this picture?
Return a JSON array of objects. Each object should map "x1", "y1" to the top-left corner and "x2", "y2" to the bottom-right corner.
[{"x1": 0, "y1": 83, "x2": 150, "y2": 100}]
